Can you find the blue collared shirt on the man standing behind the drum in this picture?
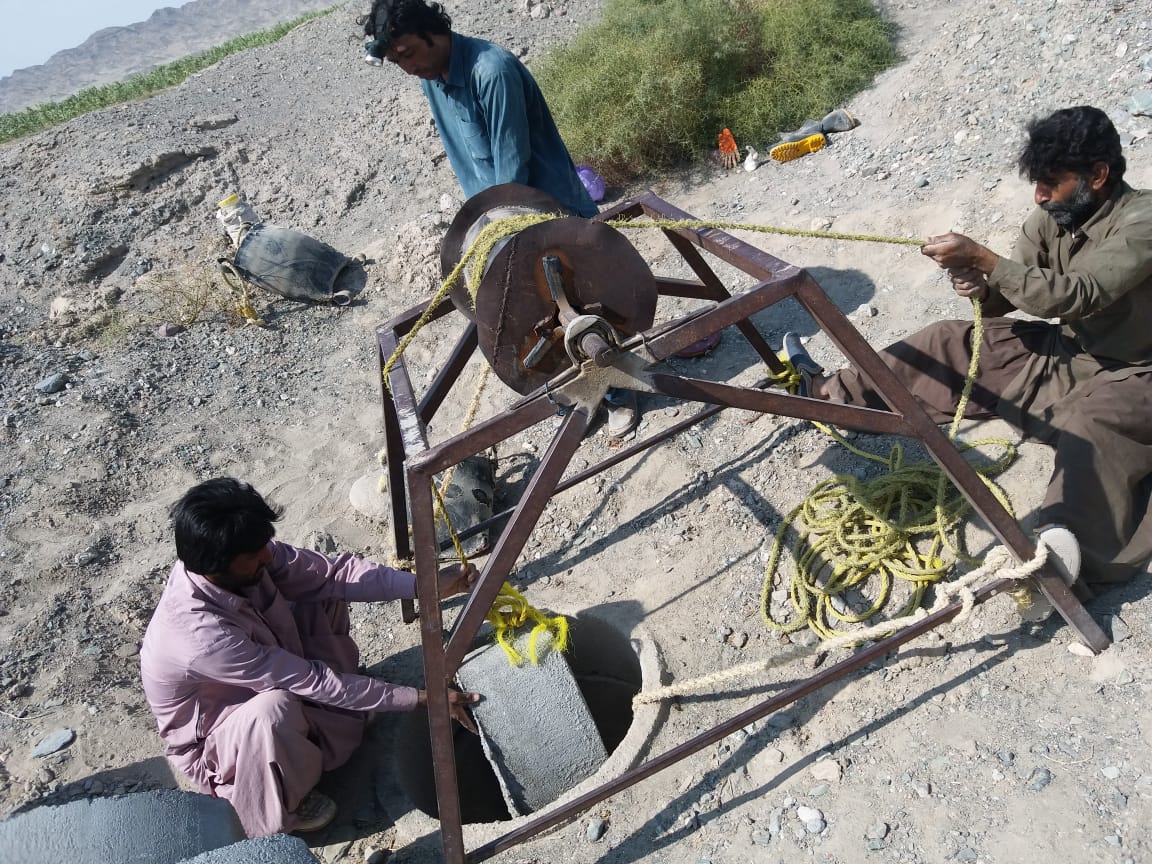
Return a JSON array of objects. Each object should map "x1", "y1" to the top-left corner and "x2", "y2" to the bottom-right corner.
[{"x1": 420, "y1": 32, "x2": 598, "y2": 217}]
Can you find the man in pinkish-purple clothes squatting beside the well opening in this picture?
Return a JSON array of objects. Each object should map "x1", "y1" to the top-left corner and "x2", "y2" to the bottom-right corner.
[{"x1": 141, "y1": 477, "x2": 479, "y2": 836}]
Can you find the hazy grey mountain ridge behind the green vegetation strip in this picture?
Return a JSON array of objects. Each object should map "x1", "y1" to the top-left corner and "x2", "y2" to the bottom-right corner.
[{"x1": 0, "y1": 0, "x2": 345, "y2": 113}]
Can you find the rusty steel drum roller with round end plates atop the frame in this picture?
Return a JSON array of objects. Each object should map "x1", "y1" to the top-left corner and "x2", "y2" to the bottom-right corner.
[{"x1": 440, "y1": 183, "x2": 658, "y2": 394}]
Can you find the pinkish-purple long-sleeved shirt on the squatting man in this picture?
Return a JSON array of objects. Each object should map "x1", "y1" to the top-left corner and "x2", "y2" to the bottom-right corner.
[{"x1": 141, "y1": 540, "x2": 418, "y2": 787}]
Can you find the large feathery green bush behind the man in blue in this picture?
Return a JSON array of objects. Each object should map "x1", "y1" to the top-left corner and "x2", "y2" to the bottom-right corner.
[{"x1": 536, "y1": 0, "x2": 895, "y2": 182}]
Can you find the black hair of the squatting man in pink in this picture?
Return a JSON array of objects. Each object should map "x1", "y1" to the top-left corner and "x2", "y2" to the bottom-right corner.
[{"x1": 170, "y1": 477, "x2": 281, "y2": 575}]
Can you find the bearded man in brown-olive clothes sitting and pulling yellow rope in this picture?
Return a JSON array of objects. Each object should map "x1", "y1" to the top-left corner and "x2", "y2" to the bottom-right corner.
[{"x1": 785, "y1": 106, "x2": 1152, "y2": 603}]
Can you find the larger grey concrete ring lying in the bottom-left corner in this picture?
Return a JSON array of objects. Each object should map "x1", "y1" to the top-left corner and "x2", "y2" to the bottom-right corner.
[{"x1": 0, "y1": 791, "x2": 244, "y2": 864}]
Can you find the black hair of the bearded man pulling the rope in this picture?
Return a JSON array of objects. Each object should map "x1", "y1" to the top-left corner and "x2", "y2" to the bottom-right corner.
[{"x1": 1018, "y1": 105, "x2": 1127, "y2": 188}]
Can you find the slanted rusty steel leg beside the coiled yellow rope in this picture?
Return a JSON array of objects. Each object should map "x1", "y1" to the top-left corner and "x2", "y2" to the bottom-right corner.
[{"x1": 796, "y1": 279, "x2": 1111, "y2": 653}]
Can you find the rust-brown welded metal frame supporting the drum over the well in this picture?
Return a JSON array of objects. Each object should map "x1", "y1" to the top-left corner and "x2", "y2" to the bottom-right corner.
[{"x1": 377, "y1": 192, "x2": 1108, "y2": 864}]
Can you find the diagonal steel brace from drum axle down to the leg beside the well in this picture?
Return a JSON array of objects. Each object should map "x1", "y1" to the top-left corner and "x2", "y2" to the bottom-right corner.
[{"x1": 445, "y1": 407, "x2": 592, "y2": 674}]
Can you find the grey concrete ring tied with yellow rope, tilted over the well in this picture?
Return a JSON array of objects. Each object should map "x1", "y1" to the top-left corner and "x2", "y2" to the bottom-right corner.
[{"x1": 456, "y1": 629, "x2": 608, "y2": 816}]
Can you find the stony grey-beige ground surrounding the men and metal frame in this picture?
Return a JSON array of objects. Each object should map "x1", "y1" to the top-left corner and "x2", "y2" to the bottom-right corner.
[{"x1": 0, "y1": 0, "x2": 1152, "y2": 864}]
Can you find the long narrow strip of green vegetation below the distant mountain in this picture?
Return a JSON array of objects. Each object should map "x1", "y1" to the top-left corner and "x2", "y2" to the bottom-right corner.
[{"x1": 0, "y1": 7, "x2": 335, "y2": 144}]
